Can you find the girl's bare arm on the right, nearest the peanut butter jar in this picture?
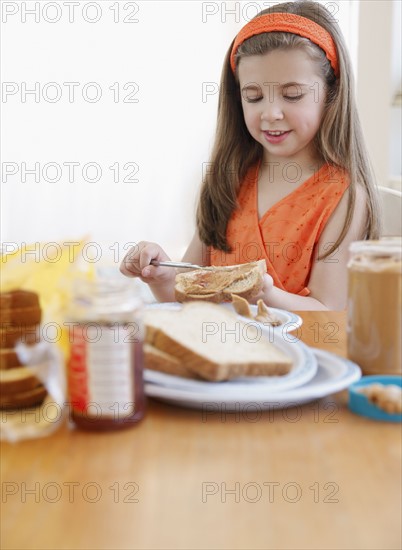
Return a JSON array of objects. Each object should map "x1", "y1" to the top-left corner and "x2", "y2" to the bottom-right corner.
[{"x1": 260, "y1": 185, "x2": 367, "y2": 311}]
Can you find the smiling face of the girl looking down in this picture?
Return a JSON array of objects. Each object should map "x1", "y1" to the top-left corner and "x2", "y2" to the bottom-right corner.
[{"x1": 238, "y1": 50, "x2": 325, "y2": 165}]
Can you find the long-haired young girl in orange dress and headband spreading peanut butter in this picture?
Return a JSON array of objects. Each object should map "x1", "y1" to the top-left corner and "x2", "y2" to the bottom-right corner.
[{"x1": 120, "y1": 1, "x2": 379, "y2": 310}]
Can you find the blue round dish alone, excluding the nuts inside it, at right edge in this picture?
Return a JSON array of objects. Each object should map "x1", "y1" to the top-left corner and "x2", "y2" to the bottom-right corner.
[{"x1": 348, "y1": 374, "x2": 402, "y2": 422}]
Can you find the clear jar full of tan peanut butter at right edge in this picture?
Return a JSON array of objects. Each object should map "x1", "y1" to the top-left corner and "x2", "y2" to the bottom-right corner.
[{"x1": 347, "y1": 237, "x2": 402, "y2": 375}]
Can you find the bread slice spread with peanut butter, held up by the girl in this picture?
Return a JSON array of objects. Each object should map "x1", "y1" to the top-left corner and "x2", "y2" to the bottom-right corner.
[{"x1": 175, "y1": 260, "x2": 267, "y2": 303}]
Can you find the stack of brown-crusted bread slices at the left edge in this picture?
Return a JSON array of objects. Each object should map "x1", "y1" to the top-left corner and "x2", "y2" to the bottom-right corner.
[{"x1": 0, "y1": 290, "x2": 47, "y2": 409}]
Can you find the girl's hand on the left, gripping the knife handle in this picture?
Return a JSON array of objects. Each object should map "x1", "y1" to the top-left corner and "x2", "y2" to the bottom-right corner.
[{"x1": 120, "y1": 241, "x2": 175, "y2": 285}]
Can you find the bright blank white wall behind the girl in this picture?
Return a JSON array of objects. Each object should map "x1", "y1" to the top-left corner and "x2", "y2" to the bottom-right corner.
[{"x1": 1, "y1": 0, "x2": 398, "y2": 266}]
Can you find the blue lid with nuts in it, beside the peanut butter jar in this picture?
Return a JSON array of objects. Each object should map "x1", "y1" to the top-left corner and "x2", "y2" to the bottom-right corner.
[{"x1": 348, "y1": 375, "x2": 402, "y2": 422}]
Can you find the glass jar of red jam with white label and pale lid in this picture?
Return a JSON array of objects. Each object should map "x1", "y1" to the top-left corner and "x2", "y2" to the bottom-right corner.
[{"x1": 65, "y1": 275, "x2": 145, "y2": 430}]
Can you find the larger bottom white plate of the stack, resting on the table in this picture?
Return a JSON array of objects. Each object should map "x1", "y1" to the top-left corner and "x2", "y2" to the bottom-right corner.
[{"x1": 145, "y1": 352, "x2": 361, "y2": 412}]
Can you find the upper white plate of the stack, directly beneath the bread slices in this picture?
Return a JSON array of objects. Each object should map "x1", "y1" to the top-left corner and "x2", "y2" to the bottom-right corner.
[{"x1": 144, "y1": 340, "x2": 317, "y2": 399}]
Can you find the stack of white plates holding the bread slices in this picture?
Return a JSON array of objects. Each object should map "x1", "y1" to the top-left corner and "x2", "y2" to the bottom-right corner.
[{"x1": 144, "y1": 304, "x2": 361, "y2": 411}]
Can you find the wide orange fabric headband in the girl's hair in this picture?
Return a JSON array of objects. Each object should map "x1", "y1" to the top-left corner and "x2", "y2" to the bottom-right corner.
[{"x1": 230, "y1": 13, "x2": 339, "y2": 76}]
